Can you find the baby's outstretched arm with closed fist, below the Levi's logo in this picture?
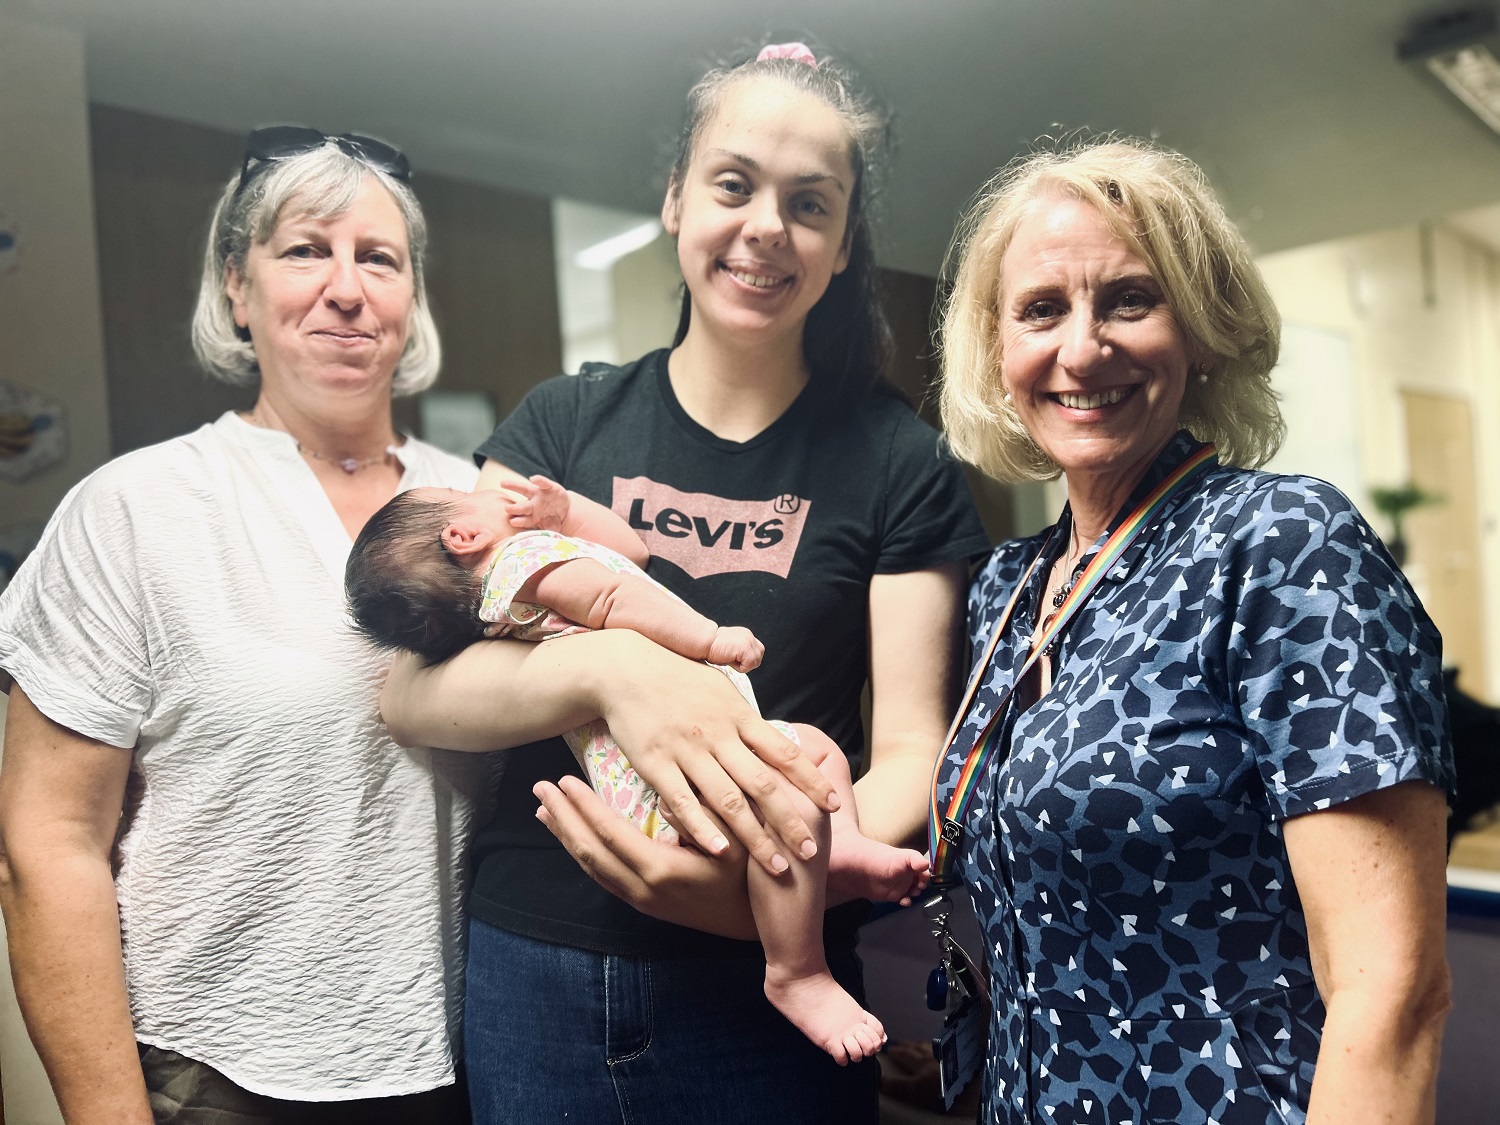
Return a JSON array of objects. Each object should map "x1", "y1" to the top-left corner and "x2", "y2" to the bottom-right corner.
[{"x1": 516, "y1": 558, "x2": 765, "y2": 672}]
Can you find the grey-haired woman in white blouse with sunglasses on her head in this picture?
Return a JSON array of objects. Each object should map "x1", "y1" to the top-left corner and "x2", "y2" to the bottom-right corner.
[{"x1": 0, "y1": 126, "x2": 485, "y2": 1125}]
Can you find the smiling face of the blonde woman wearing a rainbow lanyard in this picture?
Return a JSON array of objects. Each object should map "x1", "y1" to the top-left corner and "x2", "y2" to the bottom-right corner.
[{"x1": 998, "y1": 197, "x2": 1188, "y2": 489}]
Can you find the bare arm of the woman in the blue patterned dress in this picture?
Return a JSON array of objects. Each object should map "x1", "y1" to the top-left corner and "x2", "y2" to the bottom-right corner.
[{"x1": 1284, "y1": 782, "x2": 1449, "y2": 1125}]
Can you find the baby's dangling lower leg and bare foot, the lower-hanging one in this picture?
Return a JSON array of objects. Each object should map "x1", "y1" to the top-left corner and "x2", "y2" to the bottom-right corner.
[{"x1": 749, "y1": 768, "x2": 885, "y2": 1065}]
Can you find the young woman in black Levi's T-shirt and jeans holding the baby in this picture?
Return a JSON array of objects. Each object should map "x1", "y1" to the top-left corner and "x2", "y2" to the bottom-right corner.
[{"x1": 383, "y1": 45, "x2": 986, "y2": 1122}]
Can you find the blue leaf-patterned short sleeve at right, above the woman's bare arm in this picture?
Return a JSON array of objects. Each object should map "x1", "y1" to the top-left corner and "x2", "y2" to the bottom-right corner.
[{"x1": 1221, "y1": 477, "x2": 1454, "y2": 819}]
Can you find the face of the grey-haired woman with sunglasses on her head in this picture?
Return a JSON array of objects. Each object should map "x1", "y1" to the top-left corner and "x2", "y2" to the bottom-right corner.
[{"x1": 227, "y1": 177, "x2": 416, "y2": 407}]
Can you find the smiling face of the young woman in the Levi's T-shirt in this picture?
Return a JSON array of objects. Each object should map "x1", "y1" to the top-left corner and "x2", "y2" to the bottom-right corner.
[{"x1": 662, "y1": 78, "x2": 854, "y2": 351}]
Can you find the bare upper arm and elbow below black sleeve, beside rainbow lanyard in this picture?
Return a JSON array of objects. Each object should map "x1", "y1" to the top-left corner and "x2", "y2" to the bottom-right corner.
[{"x1": 854, "y1": 563, "x2": 966, "y2": 846}]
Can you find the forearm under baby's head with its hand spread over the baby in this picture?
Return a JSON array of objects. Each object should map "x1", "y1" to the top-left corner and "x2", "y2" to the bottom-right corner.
[{"x1": 381, "y1": 629, "x2": 839, "y2": 873}]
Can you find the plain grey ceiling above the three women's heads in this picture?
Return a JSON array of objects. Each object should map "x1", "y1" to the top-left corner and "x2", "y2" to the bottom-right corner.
[{"x1": 11, "y1": 0, "x2": 1500, "y2": 273}]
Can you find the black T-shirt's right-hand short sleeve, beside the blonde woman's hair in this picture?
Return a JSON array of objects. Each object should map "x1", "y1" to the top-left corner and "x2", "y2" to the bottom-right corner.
[{"x1": 875, "y1": 410, "x2": 990, "y2": 575}]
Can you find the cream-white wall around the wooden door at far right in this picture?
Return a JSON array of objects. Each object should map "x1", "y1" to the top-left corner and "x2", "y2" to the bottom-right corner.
[{"x1": 1260, "y1": 225, "x2": 1500, "y2": 702}]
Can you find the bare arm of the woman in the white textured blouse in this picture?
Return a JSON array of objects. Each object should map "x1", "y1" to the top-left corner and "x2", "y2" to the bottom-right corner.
[{"x1": 0, "y1": 686, "x2": 152, "y2": 1125}]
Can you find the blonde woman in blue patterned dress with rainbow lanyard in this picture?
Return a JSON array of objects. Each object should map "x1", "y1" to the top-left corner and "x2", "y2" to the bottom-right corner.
[{"x1": 932, "y1": 141, "x2": 1452, "y2": 1125}]
